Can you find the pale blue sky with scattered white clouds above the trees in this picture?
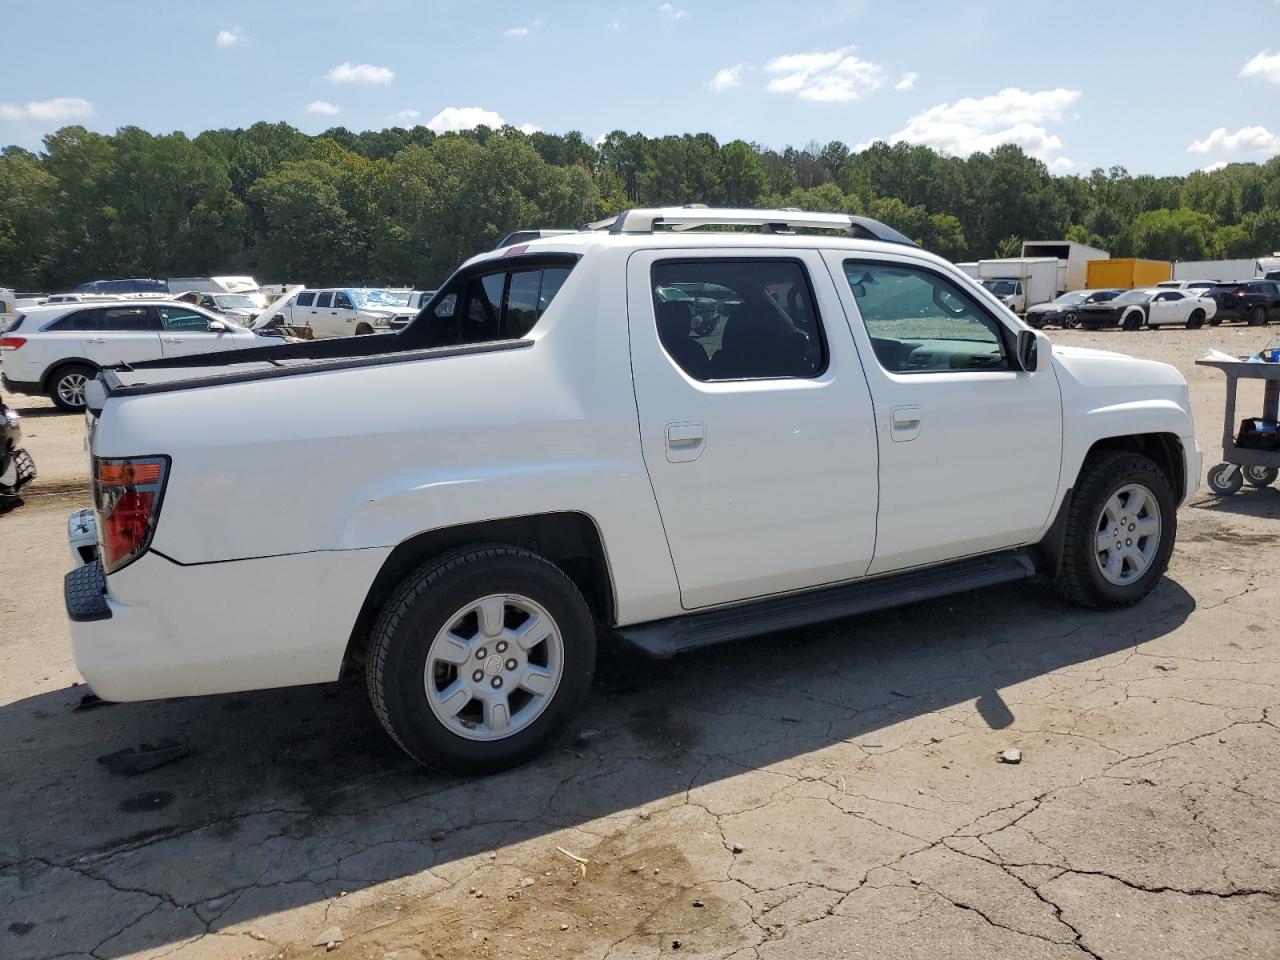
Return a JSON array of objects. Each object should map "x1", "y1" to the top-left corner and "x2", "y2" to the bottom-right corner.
[{"x1": 0, "y1": 0, "x2": 1280, "y2": 175}]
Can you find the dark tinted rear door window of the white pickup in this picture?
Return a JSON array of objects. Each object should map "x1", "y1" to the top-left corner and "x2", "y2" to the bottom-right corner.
[{"x1": 652, "y1": 260, "x2": 827, "y2": 380}]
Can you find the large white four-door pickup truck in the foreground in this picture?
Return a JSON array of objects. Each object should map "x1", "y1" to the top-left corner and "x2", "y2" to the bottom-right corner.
[{"x1": 65, "y1": 207, "x2": 1201, "y2": 772}]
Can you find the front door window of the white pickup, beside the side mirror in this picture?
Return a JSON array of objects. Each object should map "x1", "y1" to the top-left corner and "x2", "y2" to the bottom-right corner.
[{"x1": 845, "y1": 260, "x2": 1013, "y2": 374}]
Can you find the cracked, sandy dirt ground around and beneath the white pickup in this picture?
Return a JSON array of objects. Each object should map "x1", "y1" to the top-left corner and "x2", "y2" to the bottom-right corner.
[{"x1": 0, "y1": 326, "x2": 1280, "y2": 960}]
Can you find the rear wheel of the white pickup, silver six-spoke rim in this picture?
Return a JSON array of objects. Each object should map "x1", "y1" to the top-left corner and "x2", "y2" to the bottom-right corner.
[{"x1": 366, "y1": 544, "x2": 595, "y2": 774}]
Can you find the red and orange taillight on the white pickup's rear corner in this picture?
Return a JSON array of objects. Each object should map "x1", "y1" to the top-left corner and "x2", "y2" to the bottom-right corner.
[{"x1": 93, "y1": 457, "x2": 169, "y2": 573}]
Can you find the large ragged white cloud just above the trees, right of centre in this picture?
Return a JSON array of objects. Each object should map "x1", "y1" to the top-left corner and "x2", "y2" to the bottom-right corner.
[{"x1": 870, "y1": 87, "x2": 1080, "y2": 170}]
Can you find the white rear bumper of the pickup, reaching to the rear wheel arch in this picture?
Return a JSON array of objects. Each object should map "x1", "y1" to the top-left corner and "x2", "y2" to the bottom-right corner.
[{"x1": 67, "y1": 522, "x2": 390, "y2": 700}]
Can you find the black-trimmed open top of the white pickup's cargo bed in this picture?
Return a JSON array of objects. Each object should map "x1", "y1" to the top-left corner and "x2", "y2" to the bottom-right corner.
[{"x1": 102, "y1": 334, "x2": 532, "y2": 397}]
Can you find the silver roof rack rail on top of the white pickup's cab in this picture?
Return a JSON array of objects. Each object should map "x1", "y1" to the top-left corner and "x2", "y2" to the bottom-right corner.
[{"x1": 586, "y1": 204, "x2": 919, "y2": 247}]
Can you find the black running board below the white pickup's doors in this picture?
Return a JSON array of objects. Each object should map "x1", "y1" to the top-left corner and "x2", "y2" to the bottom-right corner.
[{"x1": 614, "y1": 550, "x2": 1036, "y2": 659}]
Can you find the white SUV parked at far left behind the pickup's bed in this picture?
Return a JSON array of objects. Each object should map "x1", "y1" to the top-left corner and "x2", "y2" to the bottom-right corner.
[{"x1": 0, "y1": 300, "x2": 264, "y2": 410}]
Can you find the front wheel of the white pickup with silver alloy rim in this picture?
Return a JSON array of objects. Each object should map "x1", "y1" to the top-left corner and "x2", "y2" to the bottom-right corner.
[{"x1": 1055, "y1": 451, "x2": 1178, "y2": 609}]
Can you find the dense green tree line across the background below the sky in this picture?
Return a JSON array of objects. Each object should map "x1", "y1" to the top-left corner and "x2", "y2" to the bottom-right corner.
[{"x1": 0, "y1": 123, "x2": 1280, "y2": 291}]
